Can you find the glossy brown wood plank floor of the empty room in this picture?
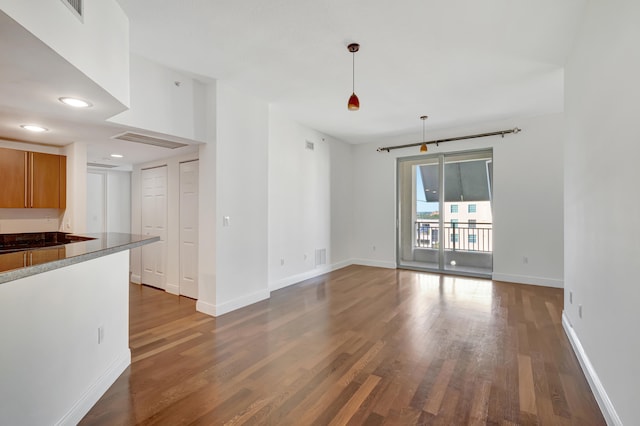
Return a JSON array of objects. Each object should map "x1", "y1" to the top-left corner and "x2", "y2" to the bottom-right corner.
[{"x1": 81, "y1": 266, "x2": 605, "y2": 426}]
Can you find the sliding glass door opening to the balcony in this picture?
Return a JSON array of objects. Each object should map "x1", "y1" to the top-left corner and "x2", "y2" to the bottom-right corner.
[{"x1": 397, "y1": 150, "x2": 493, "y2": 276}]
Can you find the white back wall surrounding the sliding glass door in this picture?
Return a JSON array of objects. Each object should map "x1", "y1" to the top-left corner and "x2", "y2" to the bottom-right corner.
[{"x1": 353, "y1": 114, "x2": 563, "y2": 287}]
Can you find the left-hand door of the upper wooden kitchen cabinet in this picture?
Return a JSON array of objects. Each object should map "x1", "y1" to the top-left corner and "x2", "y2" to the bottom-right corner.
[{"x1": 0, "y1": 148, "x2": 28, "y2": 208}]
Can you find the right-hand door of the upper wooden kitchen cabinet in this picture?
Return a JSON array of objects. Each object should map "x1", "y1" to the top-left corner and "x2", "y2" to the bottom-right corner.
[{"x1": 29, "y1": 152, "x2": 60, "y2": 209}]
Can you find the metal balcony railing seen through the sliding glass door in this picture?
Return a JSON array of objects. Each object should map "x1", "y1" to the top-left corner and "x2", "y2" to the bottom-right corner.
[{"x1": 415, "y1": 220, "x2": 493, "y2": 253}]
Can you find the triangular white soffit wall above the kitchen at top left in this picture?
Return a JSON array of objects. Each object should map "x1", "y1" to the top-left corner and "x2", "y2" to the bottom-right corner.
[{"x1": 0, "y1": 0, "x2": 129, "y2": 105}]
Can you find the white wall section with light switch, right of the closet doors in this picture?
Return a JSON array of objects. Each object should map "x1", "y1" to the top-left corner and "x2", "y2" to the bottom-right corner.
[{"x1": 198, "y1": 81, "x2": 269, "y2": 315}]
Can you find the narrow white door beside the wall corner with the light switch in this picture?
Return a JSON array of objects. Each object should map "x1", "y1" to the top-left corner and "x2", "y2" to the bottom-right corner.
[{"x1": 180, "y1": 161, "x2": 198, "y2": 299}]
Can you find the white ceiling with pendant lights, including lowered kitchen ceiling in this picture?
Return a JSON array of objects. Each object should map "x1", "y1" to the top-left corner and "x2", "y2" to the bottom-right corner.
[{"x1": 0, "y1": 0, "x2": 586, "y2": 167}]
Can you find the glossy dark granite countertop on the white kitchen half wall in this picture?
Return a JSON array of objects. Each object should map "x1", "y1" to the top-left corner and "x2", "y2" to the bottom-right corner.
[{"x1": 0, "y1": 232, "x2": 160, "y2": 284}]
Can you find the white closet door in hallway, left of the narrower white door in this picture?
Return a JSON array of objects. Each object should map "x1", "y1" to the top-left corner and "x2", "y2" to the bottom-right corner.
[{"x1": 141, "y1": 166, "x2": 167, "y2": 289}]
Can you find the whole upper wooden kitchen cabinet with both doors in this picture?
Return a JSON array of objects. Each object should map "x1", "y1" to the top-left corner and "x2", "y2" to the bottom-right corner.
[{"x1": 0, "y1": 148, "x2": 67, "y2": 209}]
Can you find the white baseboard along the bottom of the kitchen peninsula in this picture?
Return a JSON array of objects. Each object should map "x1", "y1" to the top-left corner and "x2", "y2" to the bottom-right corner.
[{"x1": 56, "y1": 348, "x2": 131, "y2": 426}]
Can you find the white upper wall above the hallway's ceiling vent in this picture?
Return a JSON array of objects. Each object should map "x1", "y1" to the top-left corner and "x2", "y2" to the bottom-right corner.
[{"x1": 108, "y1": 54, "x2": 206, "y2": 140}]
